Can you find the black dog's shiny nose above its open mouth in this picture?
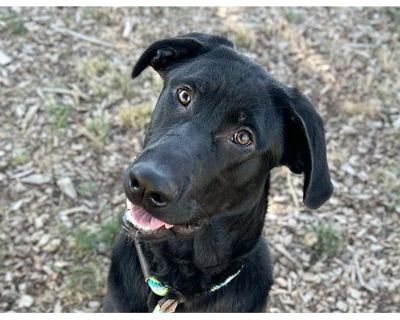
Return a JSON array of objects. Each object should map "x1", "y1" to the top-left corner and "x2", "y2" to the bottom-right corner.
[{"x1": 129, "y1": 163, "x2": 178, "y2": 208}]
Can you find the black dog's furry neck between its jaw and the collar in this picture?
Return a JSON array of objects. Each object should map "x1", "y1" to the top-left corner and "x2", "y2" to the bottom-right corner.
[{"x1": 142, "y1": 180, "x2": 269, "y2": 296}]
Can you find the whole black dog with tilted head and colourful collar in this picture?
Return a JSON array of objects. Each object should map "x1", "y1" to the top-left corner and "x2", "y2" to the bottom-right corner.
[{"x1": 104, "y1": 33, "x2": 333, "y2": 312}]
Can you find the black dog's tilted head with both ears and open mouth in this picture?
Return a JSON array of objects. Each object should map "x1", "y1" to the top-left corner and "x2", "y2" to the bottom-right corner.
[{"x1": 124, "y1": 33, "x2": 332, "y2": 238}]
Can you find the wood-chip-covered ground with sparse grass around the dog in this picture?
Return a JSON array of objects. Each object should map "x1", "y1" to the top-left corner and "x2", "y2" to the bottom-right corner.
[{"x1": 0, "y1": 7, "x2": 400, "y2": 312}]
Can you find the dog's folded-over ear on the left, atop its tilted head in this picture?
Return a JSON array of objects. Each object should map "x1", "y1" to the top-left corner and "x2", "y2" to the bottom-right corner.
[{"x1": 132, "y1": 33, "x2": 234, "y2": 78}]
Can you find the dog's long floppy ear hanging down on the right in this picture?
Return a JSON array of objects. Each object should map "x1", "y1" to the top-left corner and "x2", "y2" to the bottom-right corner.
[{"x1": 273, "y1": 87, "x2": 333, "y2": 209}]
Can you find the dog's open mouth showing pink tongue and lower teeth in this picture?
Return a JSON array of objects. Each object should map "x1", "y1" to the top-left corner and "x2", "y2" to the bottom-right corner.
[{"x1": 125, "y1": 199, "x2": 174, "y2": 232}]
